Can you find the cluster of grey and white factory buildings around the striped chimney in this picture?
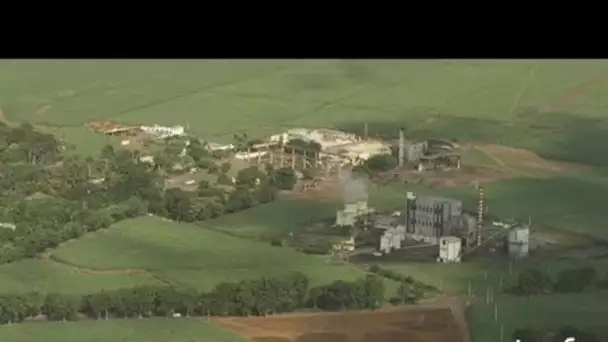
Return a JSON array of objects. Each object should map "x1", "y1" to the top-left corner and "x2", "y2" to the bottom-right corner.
[{"x1": 336, "y1": 192, "x2": 529, "y2": 263}]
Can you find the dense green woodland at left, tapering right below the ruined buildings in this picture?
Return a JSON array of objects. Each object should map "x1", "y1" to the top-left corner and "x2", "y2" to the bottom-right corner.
[{"x1": 0, "y1": 124, "x2": 295, "y2": 263}]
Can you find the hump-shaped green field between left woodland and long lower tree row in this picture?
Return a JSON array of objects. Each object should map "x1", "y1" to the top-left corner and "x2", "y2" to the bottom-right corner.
[{"x1": 48, "y1": 217, "x2": 390, "y2": 290}]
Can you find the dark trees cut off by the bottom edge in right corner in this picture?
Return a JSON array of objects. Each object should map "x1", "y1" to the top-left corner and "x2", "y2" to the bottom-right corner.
[{"x1": 512, "y1": 327, "x2": 605, "y2": 342}]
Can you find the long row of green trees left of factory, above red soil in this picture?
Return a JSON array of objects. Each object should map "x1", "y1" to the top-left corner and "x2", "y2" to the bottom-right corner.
[{"x1": 0, "y1": 272, "x2": 384, "y2": 323}]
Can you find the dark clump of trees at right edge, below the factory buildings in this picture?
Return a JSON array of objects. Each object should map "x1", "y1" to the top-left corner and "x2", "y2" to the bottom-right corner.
[{"x1": 509, "y1": 267, "x2": 608, "y2": 296}]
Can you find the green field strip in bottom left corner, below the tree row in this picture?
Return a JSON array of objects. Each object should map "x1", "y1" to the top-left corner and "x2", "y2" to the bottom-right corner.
[{"x1": 0, "y1": 318, "x2": 249, "y2": 342}]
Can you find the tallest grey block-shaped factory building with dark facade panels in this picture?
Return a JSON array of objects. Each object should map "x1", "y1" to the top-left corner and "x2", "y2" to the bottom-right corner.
[{"x1": 405, "y1": 192, "x2": 463, "y2": 243}]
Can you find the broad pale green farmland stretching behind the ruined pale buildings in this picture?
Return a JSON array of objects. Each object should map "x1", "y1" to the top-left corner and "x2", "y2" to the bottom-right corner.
[{"x1": 0, "y1": 60, "x2": 608, "y2": 165}]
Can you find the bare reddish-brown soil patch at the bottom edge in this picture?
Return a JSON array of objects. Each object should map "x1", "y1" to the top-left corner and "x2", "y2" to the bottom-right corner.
[{"x1": 214, "y1": 308, "x2": 463, "y2": 342}]
